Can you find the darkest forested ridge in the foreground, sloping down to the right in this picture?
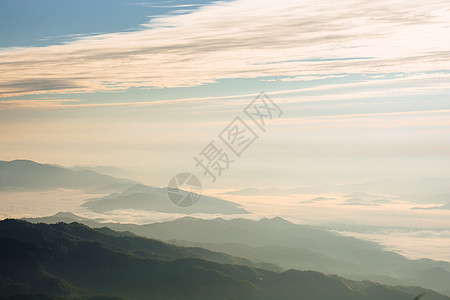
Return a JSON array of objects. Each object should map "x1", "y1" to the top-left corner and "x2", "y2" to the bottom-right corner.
[{"x1": 0, "y1": 219, "x2": 450, "y2": 300}]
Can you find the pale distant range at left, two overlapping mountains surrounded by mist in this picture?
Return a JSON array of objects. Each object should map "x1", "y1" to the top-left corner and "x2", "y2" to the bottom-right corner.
[{"x1": 0, "y1": 160, "x2": 248, "y2": 215}]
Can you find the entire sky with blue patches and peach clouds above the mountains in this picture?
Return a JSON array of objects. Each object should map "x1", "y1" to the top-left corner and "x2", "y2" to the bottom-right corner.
[{"x1": 0, "y1": 0, "x2": 450, "y2": 189}]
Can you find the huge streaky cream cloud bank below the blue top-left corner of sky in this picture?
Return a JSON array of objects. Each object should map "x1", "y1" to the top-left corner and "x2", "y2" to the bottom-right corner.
[{"x1": 0, "y1": 0, "x2": 450, "y2": 97}]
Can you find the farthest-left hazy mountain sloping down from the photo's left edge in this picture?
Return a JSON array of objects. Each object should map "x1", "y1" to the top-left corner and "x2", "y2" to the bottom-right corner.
[{"x1": 0, "y1": 160, "x2": 136, "y2": 193}]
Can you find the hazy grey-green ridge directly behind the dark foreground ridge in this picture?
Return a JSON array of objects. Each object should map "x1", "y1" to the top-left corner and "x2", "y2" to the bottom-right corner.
[{"x1": 27, "y1": 213, "x2": 450, "y2": 296}]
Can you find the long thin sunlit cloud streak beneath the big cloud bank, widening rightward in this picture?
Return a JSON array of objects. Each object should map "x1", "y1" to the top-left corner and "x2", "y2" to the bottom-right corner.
[{"x1": 0, "y1": 72, "x2": 450, "y2": 111}]
